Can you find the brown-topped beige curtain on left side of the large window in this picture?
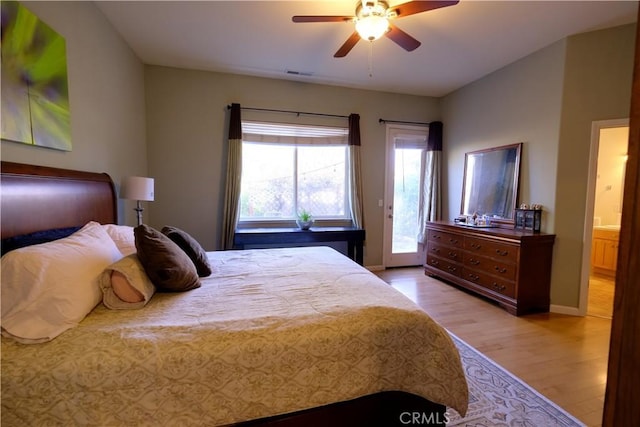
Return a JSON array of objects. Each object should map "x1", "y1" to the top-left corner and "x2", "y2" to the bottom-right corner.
[{"x1": 222, "y1": 104, "x2": 242, "y2": 249}]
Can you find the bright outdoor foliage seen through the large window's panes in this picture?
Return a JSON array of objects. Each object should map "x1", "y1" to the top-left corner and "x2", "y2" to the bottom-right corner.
[{"x1": 240, "y1": 141, "x2": 349, "y2": 221}]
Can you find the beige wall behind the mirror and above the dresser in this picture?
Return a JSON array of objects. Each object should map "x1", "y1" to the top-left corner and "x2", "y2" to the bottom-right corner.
[{"x1": 442, "y1": 41, "x2": 565, "y2": 232}]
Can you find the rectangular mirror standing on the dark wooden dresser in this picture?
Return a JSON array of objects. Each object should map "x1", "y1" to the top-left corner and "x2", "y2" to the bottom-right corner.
[{"x1": 460, "y1": 143, "x2": 522, "y2": 226}]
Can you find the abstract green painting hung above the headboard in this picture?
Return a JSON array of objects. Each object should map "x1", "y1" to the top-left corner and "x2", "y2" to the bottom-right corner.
[{"x1": 1, "y1": 1, "x2": 71, "y2": 151}]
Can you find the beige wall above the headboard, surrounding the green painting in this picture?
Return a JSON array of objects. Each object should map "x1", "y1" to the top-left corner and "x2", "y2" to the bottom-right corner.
[{"x1": 1, "y1": 2, "x2": 147, "y2": 224}]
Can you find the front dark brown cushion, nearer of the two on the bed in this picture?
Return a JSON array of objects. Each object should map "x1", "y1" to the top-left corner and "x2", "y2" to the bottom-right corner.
[{"x1": 133, "y1": 224, "x2": 200, "y2": 292}]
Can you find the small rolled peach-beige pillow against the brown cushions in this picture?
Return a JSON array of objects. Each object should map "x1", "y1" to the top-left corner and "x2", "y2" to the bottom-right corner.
[{"x1": 100, "y1": 254, "x2": 156, "y2": 310}]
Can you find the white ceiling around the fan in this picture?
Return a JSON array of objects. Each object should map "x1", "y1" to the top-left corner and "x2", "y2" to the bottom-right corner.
[{"x1": 96, "y1": 0, "x2": 637, "y2": 96}]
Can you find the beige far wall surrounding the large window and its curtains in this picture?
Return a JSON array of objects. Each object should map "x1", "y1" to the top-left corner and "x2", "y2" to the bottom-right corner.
[{"x1": 145, "y1": 66, "x2": 440, "y2": 265}]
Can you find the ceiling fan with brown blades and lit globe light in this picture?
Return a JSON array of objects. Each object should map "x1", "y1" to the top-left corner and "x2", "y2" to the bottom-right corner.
[{"x1": 291, "y1": 0, "x2": 458, "y2": 58}]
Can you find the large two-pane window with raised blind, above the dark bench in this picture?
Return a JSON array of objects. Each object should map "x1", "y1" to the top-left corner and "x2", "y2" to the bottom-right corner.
[{"x1": 240, "y1": 122, "x2": 350, "y2": 221}]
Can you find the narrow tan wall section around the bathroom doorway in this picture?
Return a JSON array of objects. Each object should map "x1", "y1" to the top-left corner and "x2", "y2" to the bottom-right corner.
[{"x1": 551, "y1": 25, "x2": 636, "y2": 306}]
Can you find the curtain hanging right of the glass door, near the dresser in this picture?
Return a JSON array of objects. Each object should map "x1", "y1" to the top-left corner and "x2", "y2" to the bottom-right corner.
[{"x1": 418, "y1": 122, "x2": 442, "y2": 244}]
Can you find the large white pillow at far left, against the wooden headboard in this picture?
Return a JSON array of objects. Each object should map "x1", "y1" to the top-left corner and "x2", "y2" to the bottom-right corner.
[{"x1": 0, "y1": 222, "x2": 122, "y2": 344}]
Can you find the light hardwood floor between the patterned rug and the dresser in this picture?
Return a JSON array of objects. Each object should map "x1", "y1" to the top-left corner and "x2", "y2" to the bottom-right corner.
[{"x1": 376, "y1": 267, "x2": 611, "y2": 426}]
